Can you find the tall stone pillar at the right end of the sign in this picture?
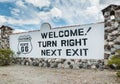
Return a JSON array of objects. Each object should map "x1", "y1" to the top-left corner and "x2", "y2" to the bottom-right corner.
[{"x1": 102, "y1": 5, "x2": 120, "y2": 59}]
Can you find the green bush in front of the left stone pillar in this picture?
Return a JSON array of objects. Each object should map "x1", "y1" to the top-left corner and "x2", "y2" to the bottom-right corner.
[{"x1": 0, "y1": 49, "x2": 14, "y2": 66}]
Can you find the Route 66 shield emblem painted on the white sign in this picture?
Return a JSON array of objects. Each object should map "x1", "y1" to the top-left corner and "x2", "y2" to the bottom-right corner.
[{"x1": 18, "y1": 35, "x2": 32, "y2": 54}]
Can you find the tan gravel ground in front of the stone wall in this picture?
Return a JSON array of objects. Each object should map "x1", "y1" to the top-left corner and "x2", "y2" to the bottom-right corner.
[{"x1": 0, "y1": 65, "x2": 120, "y2": 84}]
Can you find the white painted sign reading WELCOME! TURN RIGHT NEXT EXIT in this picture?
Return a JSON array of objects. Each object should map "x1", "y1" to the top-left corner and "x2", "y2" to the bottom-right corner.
[{"x1": 10, "y1": 23, "x2": 104, "y2": 59}]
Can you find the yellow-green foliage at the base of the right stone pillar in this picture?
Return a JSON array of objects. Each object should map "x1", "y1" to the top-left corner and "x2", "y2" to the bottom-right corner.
[{"x1": 108, "y1": 50, "x2": 120, "y2": 69}]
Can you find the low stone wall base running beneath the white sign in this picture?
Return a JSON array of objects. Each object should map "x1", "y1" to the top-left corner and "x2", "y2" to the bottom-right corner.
[{"x1": 14, "y1": 57, "x2": 104, "y2": 69}]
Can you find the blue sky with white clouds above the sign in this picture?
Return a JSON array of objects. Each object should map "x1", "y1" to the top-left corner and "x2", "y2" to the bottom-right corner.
[{"x1": 0, "y1": 0, "x2": 120, "y2": 32}]
